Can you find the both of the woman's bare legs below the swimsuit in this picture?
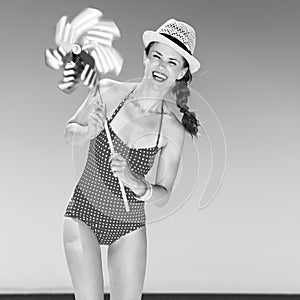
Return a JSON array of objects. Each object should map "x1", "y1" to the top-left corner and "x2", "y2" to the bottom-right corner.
[{"x1": 63, "y1": 217, "x2": 147, "y2": 300}]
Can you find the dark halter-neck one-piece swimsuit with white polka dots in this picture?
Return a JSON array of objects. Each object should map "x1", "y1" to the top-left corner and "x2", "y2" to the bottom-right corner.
[{"x1": 64, "y1": 91, "x2": 164, "y2": 245}]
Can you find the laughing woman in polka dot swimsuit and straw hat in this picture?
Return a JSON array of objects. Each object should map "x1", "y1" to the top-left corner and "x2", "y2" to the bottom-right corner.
[{"x1": 63, "y1": 19, "x2": 200, "y2": 300}]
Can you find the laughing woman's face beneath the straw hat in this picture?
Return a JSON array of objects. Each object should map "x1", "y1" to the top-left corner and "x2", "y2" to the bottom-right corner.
[{"x1": 144, "y1": 42, "x2": 187, "y2": 89}]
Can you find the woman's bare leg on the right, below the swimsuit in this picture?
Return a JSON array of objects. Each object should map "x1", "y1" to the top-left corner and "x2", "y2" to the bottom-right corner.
[{"x1": 107, "y1": 226, "x2": 147, "y2": 300}]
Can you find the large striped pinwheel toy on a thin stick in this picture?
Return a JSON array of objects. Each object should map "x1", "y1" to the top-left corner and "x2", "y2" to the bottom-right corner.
[{"x1": 45, "y1": 7, "x2": 129, "y2": 211}]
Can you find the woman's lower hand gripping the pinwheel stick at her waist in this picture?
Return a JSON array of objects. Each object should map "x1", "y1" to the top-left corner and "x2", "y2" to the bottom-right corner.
[{"x1": 109, "y1": 152, "x2": 136, "y2": 188}]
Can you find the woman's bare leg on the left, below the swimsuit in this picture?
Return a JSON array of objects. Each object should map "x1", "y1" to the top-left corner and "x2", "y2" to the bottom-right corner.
[{"x1": 63, "y1": 217, "x2": 104, "y2": 300}]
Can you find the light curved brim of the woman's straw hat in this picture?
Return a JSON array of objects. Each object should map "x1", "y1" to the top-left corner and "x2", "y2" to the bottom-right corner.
[{"x1": 142, "y1": 30, "x2": 201, "y2": 73}]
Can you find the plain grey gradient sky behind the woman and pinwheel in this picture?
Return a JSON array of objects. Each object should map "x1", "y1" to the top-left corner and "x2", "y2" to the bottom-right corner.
[{"x1": 0, "y1": 0, "x2": 300, "y2": 293}]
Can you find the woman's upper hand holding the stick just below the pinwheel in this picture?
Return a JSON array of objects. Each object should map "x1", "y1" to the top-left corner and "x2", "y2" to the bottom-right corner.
[{"x1": 87, "y1": 86, "x2": 106, "y2": 139}]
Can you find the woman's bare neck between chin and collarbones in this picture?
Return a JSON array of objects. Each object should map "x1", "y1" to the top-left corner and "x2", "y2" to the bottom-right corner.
[{"x1": 131, "y1": 80, "x2": 168, "y2": 112}]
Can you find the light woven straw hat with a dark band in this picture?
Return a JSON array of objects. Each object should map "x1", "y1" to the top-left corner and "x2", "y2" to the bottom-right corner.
[{"x1": 143, "y1": 19, "x2": 200, "y2": 73}]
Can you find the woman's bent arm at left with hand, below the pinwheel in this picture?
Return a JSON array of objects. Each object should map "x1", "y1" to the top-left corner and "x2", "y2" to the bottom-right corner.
[{"x1": 64, "y1": 79, "x2": 113, "y2": 145}]
